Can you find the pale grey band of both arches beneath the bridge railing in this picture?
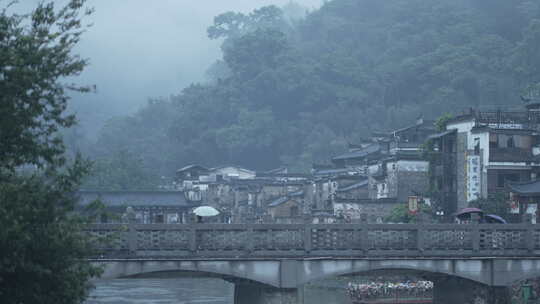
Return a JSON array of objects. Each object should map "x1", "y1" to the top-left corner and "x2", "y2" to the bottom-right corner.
[{"x1": 95, "y1": 258, "x2": 540, "y2": 288}]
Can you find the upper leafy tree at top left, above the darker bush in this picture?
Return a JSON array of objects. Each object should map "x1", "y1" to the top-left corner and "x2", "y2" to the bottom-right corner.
[{"x1": 0, "y1": 0, "x2": 91, "y2": 170}]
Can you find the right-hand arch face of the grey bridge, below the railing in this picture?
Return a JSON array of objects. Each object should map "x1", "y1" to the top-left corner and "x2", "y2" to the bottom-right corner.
[{"x1": 299, "y1": 259, "x2": 493, "y2": 285}]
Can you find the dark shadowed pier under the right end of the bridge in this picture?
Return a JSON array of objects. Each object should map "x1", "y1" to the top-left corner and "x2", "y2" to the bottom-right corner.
[{"x1": 433, "y1": 276, "x2": 511, "y2": 304}]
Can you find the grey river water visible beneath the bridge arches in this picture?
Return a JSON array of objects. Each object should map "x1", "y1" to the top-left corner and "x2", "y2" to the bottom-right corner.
[{"x1": 86, "y1": 278, "x2": 350, "y2": 304}]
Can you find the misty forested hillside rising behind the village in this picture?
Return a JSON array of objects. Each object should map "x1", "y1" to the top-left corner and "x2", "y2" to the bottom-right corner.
[{"x1": 78, "y1": 0, "x2": 540, "y2": 189}]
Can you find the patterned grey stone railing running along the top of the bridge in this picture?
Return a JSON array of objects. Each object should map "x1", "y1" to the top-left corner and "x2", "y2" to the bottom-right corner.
[{"x1": 87, "y1": 224, "x2": 540, "y2": 258}]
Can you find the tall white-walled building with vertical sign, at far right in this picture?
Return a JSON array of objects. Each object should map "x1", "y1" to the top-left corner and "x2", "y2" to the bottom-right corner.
[{"x1": 432, "y1": 103, "x2": 540, "y2": 217}]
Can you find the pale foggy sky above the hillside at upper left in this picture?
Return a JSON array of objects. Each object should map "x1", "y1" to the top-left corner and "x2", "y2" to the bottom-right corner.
[{"x1": 14, "y1": 0, "x2": 322, "y2": 135}]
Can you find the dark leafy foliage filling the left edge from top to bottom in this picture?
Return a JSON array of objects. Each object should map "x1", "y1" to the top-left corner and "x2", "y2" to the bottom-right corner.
[{"x1": 0, "y1": 0, "x2": 100, "y2": 304}]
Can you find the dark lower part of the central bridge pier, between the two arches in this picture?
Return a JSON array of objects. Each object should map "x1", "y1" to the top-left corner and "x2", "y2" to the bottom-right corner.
[{"x1": 234, "y1": 282, "x2": 304, "y2": 304}]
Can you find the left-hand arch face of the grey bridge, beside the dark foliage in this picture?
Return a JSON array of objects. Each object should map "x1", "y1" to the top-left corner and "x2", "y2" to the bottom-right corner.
[{"x1": 94, "y1": 260, "x2": 280, "y2": 287}]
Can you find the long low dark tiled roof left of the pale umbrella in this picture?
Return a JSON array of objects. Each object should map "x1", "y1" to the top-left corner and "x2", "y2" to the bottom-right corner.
[{"x1": 76, "y1": 191, "x2": 192, "y2": 207}]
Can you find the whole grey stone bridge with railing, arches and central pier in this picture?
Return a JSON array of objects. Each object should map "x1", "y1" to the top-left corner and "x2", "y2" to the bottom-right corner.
[{"x1": 88, "y1": 224, "x2": 540, "y2": 304}]
